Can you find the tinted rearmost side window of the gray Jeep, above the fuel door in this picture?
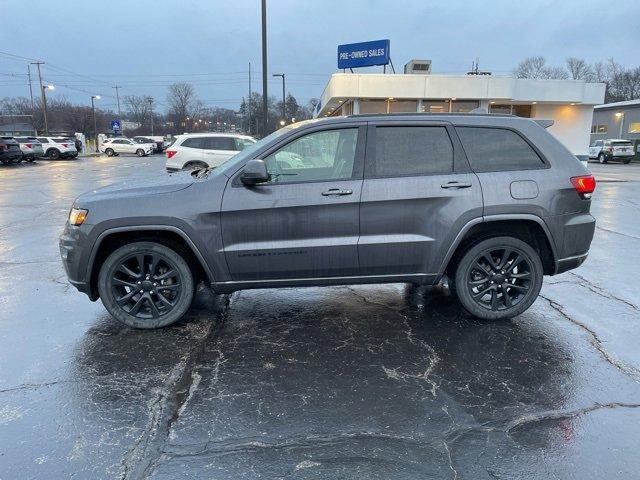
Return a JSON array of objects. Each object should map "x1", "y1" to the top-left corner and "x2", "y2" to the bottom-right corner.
[{"x1": 456, "y1": 127, "x2": 544, "y2": 172}]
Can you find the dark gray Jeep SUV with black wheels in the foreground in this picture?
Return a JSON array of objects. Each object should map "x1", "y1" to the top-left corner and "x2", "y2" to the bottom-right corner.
[{"x1": 60, "y1": 114, "x2": 595, "y2": 328}]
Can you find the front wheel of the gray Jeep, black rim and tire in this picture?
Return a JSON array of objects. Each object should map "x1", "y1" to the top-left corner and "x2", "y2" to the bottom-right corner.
[{"x1": 98, "y1": 242, "x2": 195, "y2": 329}]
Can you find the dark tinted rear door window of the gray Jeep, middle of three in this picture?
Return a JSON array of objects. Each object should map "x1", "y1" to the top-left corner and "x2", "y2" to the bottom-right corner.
[{"x1": 367, "y1": 126, "x2": 453, "y2": 177}]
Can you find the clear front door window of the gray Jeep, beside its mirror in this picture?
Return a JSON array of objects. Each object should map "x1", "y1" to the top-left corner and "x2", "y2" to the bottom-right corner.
[{"x1": 264, "y1": 128, "x2": 358, "y2": 183}]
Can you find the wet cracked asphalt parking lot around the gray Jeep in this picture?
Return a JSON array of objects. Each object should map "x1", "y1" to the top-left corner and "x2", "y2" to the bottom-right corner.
[{"x1": 0, "y1": 156, "x2": 640, "y2": 480}]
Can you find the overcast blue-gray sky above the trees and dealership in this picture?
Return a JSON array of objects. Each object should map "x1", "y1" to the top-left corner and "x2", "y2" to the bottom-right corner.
[{"x1": 0, "y1": 0, "x2": 640, "y2": 113}]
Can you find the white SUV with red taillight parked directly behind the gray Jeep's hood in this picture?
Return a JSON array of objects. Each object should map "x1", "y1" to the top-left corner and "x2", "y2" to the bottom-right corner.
[{"x1": 166, "y1": 133, "x2": 256, "y2": 172}]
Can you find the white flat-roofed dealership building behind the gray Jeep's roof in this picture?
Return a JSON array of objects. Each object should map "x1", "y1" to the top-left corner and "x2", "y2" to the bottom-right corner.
[{"x1": 316, "y1": 68, "x2": 605, "y2": 160}]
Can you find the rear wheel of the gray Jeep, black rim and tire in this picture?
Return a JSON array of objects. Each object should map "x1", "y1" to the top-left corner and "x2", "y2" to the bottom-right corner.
[{"x1": 451, "y1": 237, "x2": 544, "y2": 320}]
